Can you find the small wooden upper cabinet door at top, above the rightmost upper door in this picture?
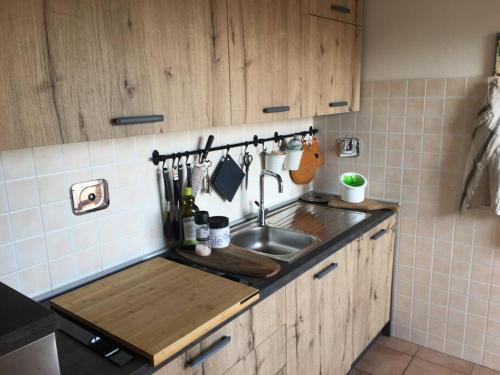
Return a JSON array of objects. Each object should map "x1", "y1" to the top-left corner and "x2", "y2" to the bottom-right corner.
[{"x1": 309, "y1": 0, "x2": 363, "y2": 25}]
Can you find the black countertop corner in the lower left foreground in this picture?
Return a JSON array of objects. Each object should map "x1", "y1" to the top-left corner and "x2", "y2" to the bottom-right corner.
[{"x1": 0, "y1": 283, "x2": 58, "y2": 357}]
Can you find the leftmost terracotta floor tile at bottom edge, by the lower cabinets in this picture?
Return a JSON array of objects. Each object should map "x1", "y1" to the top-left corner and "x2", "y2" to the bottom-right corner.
[{"x1": 355, "y1": 345, "x2": 411, "y2": 375}]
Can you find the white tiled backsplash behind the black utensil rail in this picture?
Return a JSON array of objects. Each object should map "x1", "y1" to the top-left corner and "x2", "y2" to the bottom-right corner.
[{"x1": 0, "y1": 119, "x2": 312, "y2": 297}]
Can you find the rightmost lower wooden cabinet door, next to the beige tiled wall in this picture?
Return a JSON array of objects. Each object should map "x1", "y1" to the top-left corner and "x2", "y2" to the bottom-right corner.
[{"x1": 351, "y1": 216, "x2": 396, "y2": 359}]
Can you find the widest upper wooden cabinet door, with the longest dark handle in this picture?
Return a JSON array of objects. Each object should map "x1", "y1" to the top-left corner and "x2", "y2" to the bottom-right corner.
[{"x1": 46, "y1": 0, "x2": 230, "y2": 142}]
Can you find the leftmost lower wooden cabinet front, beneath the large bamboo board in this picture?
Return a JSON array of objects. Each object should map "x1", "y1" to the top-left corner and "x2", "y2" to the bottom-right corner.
[{"x1": 155, "y1": 289, "x2": 285, "y2": 375}]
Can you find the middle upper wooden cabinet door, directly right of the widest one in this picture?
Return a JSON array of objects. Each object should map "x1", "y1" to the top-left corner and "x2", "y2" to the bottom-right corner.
[{"x1": 228, "y1": 0, "x2": 300, "y2": 124}]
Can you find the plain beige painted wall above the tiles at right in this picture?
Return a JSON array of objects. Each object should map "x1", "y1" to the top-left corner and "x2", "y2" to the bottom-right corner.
[{"x1": 363, "y1": 0, "x2": 500, "y2": 80}]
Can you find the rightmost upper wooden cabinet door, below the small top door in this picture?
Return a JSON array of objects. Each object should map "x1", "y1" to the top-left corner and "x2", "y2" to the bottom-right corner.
[{"x1": 301, "y1": 16, "x2": 361, "y2": 117}]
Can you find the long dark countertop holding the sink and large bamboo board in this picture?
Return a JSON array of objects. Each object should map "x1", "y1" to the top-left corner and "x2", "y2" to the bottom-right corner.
[{"x1": 44, "y1": 198, "x2": 395, "y2": 375}]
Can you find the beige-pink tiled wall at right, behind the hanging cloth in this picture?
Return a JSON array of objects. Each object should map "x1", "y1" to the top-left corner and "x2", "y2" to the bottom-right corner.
[{"x1": 315, "y1": 77, "x2": 500, "y2": 370}]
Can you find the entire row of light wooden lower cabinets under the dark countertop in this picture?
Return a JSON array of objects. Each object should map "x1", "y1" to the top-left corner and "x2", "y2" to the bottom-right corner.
[{"x1": 156, "y1": 216, "x2": 396, "y2": 375}]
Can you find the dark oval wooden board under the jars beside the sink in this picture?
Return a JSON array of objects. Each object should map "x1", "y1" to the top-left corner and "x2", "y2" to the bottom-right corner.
[{"x1": 176, "y1": 244, "x2": 281, "y2": 278}]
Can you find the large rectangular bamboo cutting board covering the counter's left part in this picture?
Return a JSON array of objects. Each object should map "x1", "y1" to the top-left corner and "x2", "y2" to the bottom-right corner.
[{"x1": 51, "y1": 258, "x2": 259, "y2": 366}]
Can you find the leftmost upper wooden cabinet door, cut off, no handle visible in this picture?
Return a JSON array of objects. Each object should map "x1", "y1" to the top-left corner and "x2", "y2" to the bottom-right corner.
[{"x1": 0, "y1": 0, "x2": 62, "y2": 150}]
